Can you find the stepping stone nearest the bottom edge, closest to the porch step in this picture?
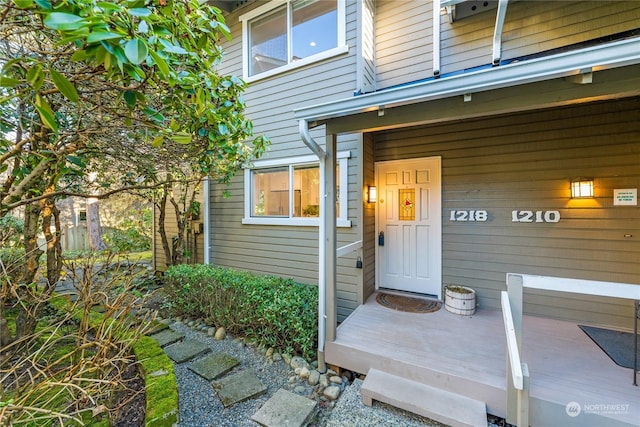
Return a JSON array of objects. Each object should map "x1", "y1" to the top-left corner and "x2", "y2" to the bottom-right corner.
[{"x1": 251, "y1": 389, "x2": 316, "y2": 427}]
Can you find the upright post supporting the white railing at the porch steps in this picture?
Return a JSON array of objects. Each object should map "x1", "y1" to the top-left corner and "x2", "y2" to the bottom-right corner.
[{"x1": 507, "y1": 273, "x2": 528, "y2": 427}]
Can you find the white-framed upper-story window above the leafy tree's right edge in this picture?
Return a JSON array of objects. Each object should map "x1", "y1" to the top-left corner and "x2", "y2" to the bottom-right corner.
[{"x1": 240, "y1": 0, "x2": 348, "y2": 81}]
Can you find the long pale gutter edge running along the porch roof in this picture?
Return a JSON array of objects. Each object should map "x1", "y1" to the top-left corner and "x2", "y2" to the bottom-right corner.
[{"x1": 294, "y1": 38, "x2": 640, "y2": 128}]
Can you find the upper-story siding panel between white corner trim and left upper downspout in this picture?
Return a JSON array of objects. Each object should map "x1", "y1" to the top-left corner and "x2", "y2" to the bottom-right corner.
[{"x1": 376, "y1": 0, "x2": 433, "y2": 89}]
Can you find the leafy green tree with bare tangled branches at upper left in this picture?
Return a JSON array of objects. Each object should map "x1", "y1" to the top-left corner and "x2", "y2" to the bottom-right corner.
[{"x1": 0, "y1": 0, "x2": 268, "y2": 342}]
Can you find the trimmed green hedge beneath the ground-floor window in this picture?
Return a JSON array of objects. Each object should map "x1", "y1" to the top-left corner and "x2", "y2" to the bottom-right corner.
[{"x1": 165, "y1": 264, "x2": 318, "y2": 357}]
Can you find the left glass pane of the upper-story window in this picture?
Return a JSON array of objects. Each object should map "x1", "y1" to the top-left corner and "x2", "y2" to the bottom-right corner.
[{"x1": 249, "y1": 6, "x2": 288, "y2": 75}]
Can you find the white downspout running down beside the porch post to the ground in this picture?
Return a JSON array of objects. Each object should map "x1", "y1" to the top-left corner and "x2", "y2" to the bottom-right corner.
[{"x1": 298, "y1": 119, "x2": 327, "y2": 372}]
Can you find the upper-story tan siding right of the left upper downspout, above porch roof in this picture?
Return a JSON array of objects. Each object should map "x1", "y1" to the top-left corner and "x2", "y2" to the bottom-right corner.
[{"x1": 440, "y1": 0, "x2": 640, "y2": 73}]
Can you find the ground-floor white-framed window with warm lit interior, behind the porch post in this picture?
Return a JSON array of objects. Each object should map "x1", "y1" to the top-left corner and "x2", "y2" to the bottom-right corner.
[{"x1": 242, "y1": 152, "x2": 351, "y2": 227}]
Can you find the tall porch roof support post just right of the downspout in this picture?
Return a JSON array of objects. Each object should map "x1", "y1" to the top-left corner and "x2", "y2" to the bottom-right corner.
[{"x1": 328, "y1": 133, "x2": 338, "y2": 342}]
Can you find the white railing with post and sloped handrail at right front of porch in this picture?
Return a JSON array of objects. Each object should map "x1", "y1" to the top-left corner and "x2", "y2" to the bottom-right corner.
[{"x1": 501, "y1": 273, "x2": 640, "y2": 426}]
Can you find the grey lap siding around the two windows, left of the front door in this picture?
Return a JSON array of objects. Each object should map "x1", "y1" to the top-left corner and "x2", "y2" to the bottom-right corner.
[{"x1": 210, "y1": 1, "x2": 362, "y2": 319}]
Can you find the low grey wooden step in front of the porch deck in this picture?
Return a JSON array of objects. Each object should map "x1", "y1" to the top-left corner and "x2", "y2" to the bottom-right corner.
[{"x1": 361, "y1": 369, "x2": 487, "y2": 427}]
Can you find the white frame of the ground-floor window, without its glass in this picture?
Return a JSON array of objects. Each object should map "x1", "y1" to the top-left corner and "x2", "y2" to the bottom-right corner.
[{"x1": 242, "y1": 151, "x2": 351, "y2": 227}]
